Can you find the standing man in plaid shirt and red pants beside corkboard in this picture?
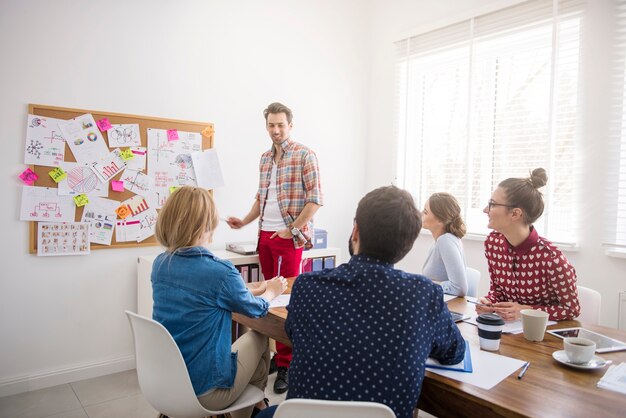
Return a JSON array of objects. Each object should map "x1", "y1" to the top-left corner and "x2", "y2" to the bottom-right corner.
[{"x1": 227, "y1": 103, "x2": 323, "y2": 393}]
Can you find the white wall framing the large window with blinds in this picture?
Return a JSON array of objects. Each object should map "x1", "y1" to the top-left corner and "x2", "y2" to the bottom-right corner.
[{"x1": 367, "y1": 0, "x2": 626, "y2": 327}]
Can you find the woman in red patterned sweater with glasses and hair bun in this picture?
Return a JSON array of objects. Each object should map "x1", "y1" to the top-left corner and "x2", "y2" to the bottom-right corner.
[{"x1": 476, "y1": 168, "x2": 580, "y2": 321}]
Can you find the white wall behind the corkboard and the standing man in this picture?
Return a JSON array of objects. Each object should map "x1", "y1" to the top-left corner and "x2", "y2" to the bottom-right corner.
[{"x1": 0, "y1": 0, "x2": 369, "y2": 396}]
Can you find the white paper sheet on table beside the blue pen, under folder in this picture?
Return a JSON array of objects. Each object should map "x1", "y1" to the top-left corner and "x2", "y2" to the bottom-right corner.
[{"x1": 428, "y1": 345, "x2": 532, "y2": 390}]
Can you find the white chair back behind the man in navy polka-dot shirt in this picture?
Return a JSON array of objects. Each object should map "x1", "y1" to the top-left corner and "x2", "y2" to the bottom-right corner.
[{"x1": 274, "y1": 399, "x2": 396, "y2": 418}]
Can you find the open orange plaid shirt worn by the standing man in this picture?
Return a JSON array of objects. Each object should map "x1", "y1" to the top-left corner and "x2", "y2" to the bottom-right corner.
[{"x1": 256, "y1": 139, "x2": 323, "y2": 248}]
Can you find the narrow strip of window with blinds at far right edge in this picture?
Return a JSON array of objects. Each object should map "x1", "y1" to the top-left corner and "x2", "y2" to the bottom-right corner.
[{"x1": 604, "y1": 0, "x2": 626, "y2": 247}]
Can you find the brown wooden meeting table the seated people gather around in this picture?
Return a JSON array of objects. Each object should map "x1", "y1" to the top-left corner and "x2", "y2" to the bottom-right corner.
[{"x1": 233, "y1": 283, "x2": 626, "y2": 417}]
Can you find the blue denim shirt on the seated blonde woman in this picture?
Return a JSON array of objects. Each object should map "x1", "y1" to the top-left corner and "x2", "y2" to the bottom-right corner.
[{"x1": 152, "y1": 247, "x2": 269, "y2": 395}]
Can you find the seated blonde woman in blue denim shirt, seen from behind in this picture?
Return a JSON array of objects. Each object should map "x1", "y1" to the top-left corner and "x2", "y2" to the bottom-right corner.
[{"x1": 152, "y1": 186, "x2": 287, "y2": 418}]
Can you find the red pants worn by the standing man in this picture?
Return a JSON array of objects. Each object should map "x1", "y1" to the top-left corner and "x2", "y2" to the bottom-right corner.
[{"x1": 259, "y1": 231, "x2": 302, "y2": 367}]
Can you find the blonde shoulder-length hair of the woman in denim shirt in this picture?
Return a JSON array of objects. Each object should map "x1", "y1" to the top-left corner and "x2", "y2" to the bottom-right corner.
[{"x1": 155, "y1": 186, "x2": 219, "y2": 253}]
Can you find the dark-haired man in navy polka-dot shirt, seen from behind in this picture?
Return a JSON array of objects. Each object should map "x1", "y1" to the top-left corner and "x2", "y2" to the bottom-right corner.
[{"x1": 262, "y1": 186, "x2": 465, "y2": 418}]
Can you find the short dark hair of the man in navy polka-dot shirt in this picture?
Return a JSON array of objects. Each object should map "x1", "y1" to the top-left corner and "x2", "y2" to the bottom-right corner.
[{"x1": 355, "y1": 186, "x2": 422, "y2": 263}]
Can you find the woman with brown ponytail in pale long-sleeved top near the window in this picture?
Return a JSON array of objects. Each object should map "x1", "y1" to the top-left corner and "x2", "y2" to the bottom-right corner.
[{"x1": 422, "y1": 193, "x2": 467, "y2": 296}]
